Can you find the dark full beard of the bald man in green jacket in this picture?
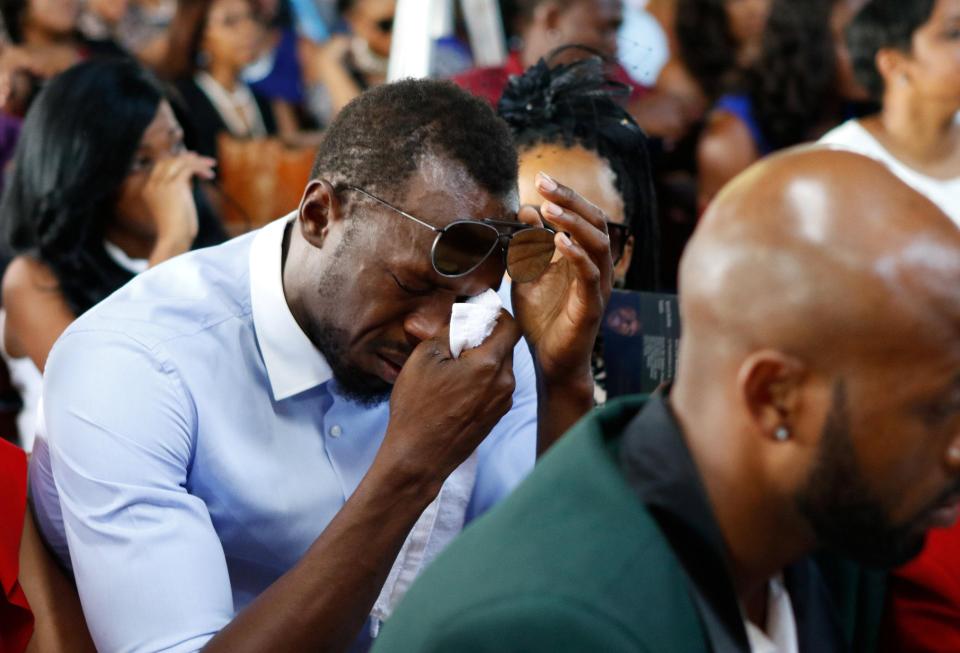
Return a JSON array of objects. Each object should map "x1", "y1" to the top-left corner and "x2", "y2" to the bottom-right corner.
[{"x1": 796, "y1": 381, "x2": 936, "y2": 569}]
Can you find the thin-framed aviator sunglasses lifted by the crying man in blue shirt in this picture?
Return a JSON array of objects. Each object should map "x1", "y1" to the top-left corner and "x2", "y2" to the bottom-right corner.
[{"x1": 343, "y1": 186, "x2": 556, "y2": 283}]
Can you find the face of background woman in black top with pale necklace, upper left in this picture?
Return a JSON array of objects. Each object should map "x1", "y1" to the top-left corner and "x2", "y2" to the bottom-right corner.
[{"x1": 201, "y1": 0, "x2": 263, "y2": 73}]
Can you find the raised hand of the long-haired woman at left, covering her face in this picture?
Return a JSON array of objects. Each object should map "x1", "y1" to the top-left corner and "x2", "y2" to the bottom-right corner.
[{"x1": 143, "y1": 152, "x2": 216, "y2": 266}]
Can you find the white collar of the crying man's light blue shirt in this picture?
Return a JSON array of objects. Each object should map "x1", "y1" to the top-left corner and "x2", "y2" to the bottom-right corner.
[{"x1": 250, "y1": 213, "x2": 333, "y2": 401}]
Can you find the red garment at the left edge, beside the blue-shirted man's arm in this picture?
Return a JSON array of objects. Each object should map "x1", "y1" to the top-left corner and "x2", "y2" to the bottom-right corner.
[{"x1": 0, "y1": 440, "x2": 33, "y2": 653}]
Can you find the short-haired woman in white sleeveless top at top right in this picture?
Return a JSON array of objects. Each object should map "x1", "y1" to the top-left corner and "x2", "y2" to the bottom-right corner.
[{"x1": 821, "y1": 0, "x2": 960, "y2": 224}]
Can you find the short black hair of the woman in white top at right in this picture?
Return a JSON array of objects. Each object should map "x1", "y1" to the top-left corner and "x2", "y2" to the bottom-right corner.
[{"x1": 847, "y1": 0, "x2": 936, "y2": 101}]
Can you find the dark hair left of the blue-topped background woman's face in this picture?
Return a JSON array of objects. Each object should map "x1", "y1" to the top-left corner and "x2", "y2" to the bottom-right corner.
[{"x1": 675, "y1": 0, "x2": 737, "y2": 99}]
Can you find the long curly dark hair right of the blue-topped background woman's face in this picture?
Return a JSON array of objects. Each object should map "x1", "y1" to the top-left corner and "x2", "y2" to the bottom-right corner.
[{"x1": 744, "y1": 0, "x2": 836, "y2": 149}]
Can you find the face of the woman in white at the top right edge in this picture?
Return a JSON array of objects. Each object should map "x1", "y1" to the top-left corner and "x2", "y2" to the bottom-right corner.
[{"x1": 904, "y1": 0, "x2": 960, "y2": 111}]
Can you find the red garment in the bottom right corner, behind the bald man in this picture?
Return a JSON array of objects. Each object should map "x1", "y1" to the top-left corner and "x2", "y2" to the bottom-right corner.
[{"x1": 883, "y1": 524, "x2": 960, "y2": 653}]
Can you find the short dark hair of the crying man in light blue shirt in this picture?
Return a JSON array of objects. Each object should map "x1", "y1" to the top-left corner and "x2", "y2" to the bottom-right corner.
[{"x1": 312, "y1": 79, "x2": 517, "y2": 201}]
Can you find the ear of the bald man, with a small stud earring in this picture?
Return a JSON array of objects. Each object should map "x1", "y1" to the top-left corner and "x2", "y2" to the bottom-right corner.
[{"x1": 737, "y1": 350, "x2": 808, "y2": 440}]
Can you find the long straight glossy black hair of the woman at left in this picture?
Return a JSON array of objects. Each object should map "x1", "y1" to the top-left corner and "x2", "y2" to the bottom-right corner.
[{"x1": 0, "y1": 59, "x2": 176, "y2": 314}]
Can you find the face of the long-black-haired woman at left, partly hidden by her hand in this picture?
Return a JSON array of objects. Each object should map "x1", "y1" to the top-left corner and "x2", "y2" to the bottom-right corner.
[{"x1": 113, "y1": 100, "x2": 183, "y2": 240}]
